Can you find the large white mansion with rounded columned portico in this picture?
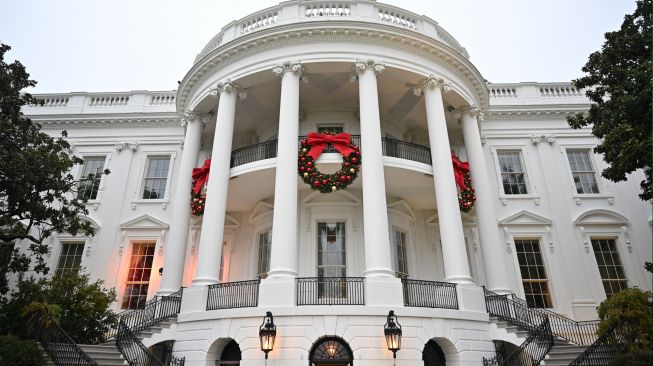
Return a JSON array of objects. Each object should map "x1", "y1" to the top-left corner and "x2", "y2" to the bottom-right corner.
[{"x1": 20, "y1": 0, "x2": 652, "y2": 366}]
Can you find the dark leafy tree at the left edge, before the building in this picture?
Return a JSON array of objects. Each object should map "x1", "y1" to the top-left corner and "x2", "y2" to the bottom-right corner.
[{"x1": 0, "y1": 44, "x2": 108, "y2": 295}]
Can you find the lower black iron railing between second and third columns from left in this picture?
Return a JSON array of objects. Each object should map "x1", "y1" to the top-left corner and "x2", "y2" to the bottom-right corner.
[{"x1": 206, "y1": 280, "x2": 261, "y2": 310}]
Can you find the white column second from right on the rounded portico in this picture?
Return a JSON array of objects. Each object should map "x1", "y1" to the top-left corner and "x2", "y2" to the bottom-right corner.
[{"x1": 414, "y1": 76, "x2": 472, "y2": 284}]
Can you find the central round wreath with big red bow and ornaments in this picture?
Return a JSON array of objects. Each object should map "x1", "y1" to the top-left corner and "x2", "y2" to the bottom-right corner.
[{"x1": 297, "y1": 132, "x2": 361, "y2": 193}]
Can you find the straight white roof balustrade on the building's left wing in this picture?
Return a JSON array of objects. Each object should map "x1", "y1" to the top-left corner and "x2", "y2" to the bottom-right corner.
[{"x1": 23, "y1": 90, "x2": 177, "y2": 115}]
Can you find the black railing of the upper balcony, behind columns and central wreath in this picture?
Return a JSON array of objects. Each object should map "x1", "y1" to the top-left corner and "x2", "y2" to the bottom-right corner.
[{"x1": 231, "y1": 135, "x2": 431, "y2": 168}]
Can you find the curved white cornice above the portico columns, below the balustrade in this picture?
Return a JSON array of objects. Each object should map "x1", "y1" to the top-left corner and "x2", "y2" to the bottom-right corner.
[{"x1": 176, "y1": 21, "x2": 489, "y2": 110}]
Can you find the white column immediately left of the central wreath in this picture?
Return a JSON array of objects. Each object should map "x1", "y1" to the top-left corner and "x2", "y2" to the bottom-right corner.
[{"x1": 269, "y1": 63, "x2": 302, "y2": 278}]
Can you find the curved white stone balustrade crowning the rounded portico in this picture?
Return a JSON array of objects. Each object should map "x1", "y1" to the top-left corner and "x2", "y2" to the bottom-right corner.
[{"x1": 195, "y1": 0, "x2": 469, "y2": 62}]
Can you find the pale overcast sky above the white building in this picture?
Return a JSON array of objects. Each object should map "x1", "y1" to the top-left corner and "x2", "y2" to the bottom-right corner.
[{"x1": 0, "y1": 0, "x2": 635, "y2": 93}]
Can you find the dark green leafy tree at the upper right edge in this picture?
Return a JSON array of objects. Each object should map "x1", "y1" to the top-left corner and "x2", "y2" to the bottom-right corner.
[{"x1": 567, "y1": 0, "x2": 653, "y2": 200}]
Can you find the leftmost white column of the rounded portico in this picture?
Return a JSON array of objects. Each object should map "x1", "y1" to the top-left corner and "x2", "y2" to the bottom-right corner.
[{"x1": 159, "y1": 112, "x2": 203, "y2": 295}]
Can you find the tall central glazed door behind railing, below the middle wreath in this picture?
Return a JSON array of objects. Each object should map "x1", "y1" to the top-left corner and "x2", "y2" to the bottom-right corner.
[{"x1": 317, "y1": 222, "x2": 347, "y2": 298}]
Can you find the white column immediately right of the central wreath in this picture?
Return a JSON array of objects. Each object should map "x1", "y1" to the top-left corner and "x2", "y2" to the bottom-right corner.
[{"x1": 355, "y1": 61, "x2": 395, "y2": 278}]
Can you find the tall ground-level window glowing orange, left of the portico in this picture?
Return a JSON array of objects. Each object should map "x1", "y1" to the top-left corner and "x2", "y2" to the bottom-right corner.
[{"x1": 122, "y1": 242, "x2": 155, "y2": 309}]
